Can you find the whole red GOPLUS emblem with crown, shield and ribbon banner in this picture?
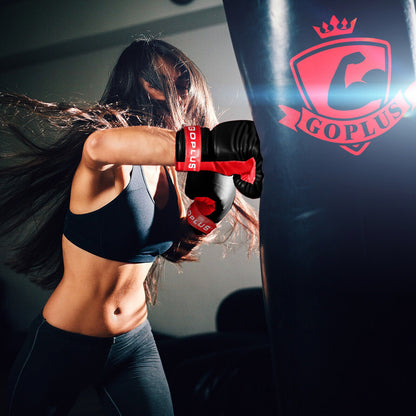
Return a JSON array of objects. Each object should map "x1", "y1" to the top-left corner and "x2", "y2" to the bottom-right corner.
[{"x1": 279, "y1": 16, "x2": 416, "y2": 155}]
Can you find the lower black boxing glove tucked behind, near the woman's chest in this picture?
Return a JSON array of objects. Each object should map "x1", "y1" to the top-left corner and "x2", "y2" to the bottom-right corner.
[{"x1": 185, "y1": 171, "x2": 235, "y2": 234}]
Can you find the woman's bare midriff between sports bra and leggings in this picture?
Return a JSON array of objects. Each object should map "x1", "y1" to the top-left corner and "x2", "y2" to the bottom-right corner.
[{"x1": 43, "y1": 237, "x2": 152, "y2": 337}]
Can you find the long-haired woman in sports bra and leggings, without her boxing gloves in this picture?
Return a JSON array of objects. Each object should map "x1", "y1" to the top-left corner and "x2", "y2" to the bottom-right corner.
[{"x1": 0, "y1": 40, "x2": 257, "y2": 415}]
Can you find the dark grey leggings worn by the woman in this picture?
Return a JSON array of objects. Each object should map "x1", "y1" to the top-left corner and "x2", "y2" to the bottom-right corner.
[{"x1": 6, "y1": 315, "x2": 173, "y2": 416}]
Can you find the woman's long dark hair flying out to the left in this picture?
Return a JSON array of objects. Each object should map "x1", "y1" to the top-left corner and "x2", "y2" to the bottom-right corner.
[{"x1": 0, "y1": 39, "x2": 258, "y2": 302}]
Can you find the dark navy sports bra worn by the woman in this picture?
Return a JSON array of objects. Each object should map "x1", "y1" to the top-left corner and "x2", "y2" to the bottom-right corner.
[{"x1": 64, "y1": 166, "x2": 179, "y2": 263}]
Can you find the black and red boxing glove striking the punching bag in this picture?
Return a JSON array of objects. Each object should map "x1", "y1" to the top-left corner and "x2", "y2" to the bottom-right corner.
[{"x1": 175, "y1": 120, "x2": 263, "y2": 198}]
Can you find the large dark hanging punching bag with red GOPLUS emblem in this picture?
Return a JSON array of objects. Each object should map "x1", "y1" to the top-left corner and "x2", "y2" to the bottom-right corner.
[{"x1": 224, "y1": 0, "x2": 416, "y2": 416}]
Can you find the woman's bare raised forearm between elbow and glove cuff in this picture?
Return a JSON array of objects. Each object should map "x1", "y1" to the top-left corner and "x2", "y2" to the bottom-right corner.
[{"x1": 83, "y1": 126, "x2": 176, "y2": 171}]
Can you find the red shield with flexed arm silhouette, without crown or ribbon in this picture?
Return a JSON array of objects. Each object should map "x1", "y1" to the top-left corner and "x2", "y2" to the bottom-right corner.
[{"x1": 290, "y1": 38, "x2": 391, "y2": 120}]
